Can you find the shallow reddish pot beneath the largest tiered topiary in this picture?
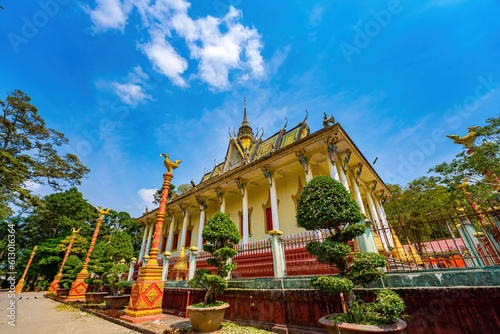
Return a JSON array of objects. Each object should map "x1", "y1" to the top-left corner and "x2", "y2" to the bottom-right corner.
[{"x1": 319, "y1": 315, "x2": 406, "y2": 334}]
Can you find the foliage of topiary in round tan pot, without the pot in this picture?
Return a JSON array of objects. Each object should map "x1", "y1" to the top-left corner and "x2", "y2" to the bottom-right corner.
[{"x1": 189, "y1": 212, "x2": 240, "y2": 306}]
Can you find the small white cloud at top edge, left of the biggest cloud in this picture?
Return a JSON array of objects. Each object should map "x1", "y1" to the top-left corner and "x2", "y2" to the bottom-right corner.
[{"x1": 84, "y1": 0, "x2": 132, "y2": 32}]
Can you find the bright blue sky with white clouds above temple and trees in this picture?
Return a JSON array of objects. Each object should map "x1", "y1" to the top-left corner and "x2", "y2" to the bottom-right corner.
[{"x1": 0, "y1": 0, "x2": 500, "y2": 216}]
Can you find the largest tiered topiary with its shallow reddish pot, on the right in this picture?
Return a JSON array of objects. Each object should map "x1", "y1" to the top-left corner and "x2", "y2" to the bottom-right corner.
[{"x1": 297, "y1": 176, "x2": 406, "y2": 334}]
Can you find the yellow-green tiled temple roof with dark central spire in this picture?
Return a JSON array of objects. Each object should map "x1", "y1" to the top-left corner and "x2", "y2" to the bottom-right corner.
[{"x1": 200, "y1": 103, "x2": 310, "y2": 184}]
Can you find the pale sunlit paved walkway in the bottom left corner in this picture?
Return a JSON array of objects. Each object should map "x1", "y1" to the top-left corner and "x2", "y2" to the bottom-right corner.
[{"x1": 0, "y1": 292, "x2": 138, "y2": 334}]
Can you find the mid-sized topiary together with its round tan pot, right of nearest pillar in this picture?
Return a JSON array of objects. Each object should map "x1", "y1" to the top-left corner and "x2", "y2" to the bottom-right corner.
[{"x1": 186, "y1": 212, "x2": 240, "y2": 332}]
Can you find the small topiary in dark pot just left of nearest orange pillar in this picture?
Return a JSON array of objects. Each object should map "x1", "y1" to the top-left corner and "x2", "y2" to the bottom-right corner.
[{"x1": 102, "y1": 263, "x2": 132, "y2": 309}]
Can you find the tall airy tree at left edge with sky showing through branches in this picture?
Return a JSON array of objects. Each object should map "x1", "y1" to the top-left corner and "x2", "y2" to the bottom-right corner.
[{"x1": 0, "y1": 90, "x2": 90, "y2": 215}]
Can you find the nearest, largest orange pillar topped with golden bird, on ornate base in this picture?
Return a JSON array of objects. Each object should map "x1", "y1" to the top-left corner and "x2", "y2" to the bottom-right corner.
[{"x1": 120, "y1": 157, "x2": 180, "y2": 323}]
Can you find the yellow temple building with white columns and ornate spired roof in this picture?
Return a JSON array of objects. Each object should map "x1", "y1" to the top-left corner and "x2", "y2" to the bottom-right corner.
[{"x1": 137, "y1": 102, "x2": 393, "y2": 262}]
